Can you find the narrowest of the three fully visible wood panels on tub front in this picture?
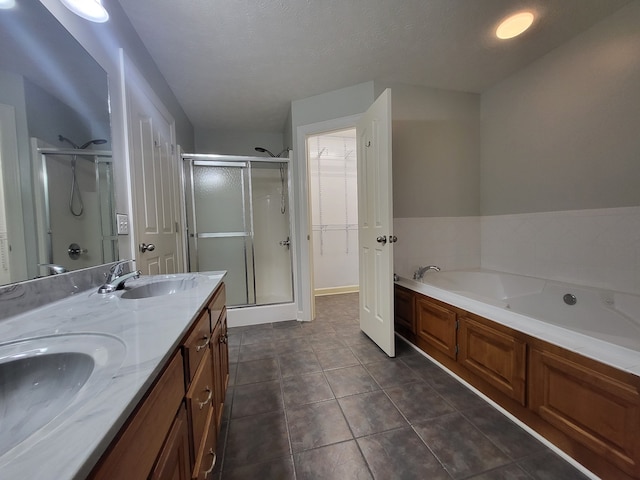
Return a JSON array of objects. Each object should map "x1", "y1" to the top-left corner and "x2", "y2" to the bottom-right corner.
[{"x1": 415, "y1": 295, "x2": 457, "y2": 360}]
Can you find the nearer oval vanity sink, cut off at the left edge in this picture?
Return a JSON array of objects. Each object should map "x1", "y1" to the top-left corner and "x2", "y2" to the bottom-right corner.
[{"x1": 0, "y1": 334, "x2": 126, "y2": 457}]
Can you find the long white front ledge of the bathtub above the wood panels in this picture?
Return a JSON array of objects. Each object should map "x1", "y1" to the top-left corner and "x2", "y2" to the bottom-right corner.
[{"x1": 395, "y1": 277, "x2": 640, "y2": 376}]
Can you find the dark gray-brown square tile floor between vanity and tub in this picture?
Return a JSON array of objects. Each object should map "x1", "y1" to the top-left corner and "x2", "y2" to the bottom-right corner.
[{"x1": 214, "y1": 294, "x2": 586, "y2": 480}]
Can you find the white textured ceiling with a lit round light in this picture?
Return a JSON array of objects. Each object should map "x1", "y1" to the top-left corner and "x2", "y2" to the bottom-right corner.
[{"x1": 118, "y1": 0, "x2": 637, "y2": 132}]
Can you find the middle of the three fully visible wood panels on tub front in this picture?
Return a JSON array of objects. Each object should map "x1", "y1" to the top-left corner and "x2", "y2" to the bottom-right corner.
[{"x1": 458, "y1": 315, "x2": 527, "y2": 405}]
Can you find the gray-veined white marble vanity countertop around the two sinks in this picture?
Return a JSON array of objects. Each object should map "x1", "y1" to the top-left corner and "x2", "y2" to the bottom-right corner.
[{"x1": 0, "y1": 272, "x2": 225, "y2": 480}]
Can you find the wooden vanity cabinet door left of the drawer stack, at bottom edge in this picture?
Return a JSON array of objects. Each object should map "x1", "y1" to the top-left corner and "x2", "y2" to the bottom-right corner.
[{"x1": 149, "y1": 407, "x2": 191, "y2": 480}]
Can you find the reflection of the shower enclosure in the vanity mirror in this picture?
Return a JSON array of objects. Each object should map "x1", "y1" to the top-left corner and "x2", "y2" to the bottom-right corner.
[{"x1": 31, "y1": 138, "x2": 118, "y2": 275}]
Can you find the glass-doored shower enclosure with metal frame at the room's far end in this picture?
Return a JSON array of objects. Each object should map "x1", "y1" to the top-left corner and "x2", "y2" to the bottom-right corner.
[{"x1": 183, "y1": 154, "x2": 293, "y2": 306}]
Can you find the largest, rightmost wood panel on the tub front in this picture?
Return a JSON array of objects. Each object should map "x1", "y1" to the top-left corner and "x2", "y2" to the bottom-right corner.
[{"x1": 529, "y1": 349, "x2": 640, "y2": 478}]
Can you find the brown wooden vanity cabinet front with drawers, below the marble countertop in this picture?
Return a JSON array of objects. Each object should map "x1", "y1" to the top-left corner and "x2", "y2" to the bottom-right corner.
[{"x1": 89, "y1": 283, "x2": 228, "y2": 480}]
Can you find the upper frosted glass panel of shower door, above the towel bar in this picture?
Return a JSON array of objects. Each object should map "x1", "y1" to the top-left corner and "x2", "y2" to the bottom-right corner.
[{"x1": 193, "y1": 166, "x2": 248, "y2": 233}]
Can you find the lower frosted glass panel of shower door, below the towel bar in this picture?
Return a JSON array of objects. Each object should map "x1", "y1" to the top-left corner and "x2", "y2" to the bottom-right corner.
[{"x1": 198, "y1": 237, "x2": 253, "y2": 306}]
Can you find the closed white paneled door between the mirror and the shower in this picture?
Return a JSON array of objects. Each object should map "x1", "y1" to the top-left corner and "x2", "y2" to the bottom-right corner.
[{"x1": 127, "y1": 70, "x2": 182, "y2": 275}]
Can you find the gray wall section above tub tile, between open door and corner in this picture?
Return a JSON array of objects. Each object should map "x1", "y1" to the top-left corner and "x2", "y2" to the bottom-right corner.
[{"x1": 376, "y1": 83, "x2": 480, "y2": 218}]
